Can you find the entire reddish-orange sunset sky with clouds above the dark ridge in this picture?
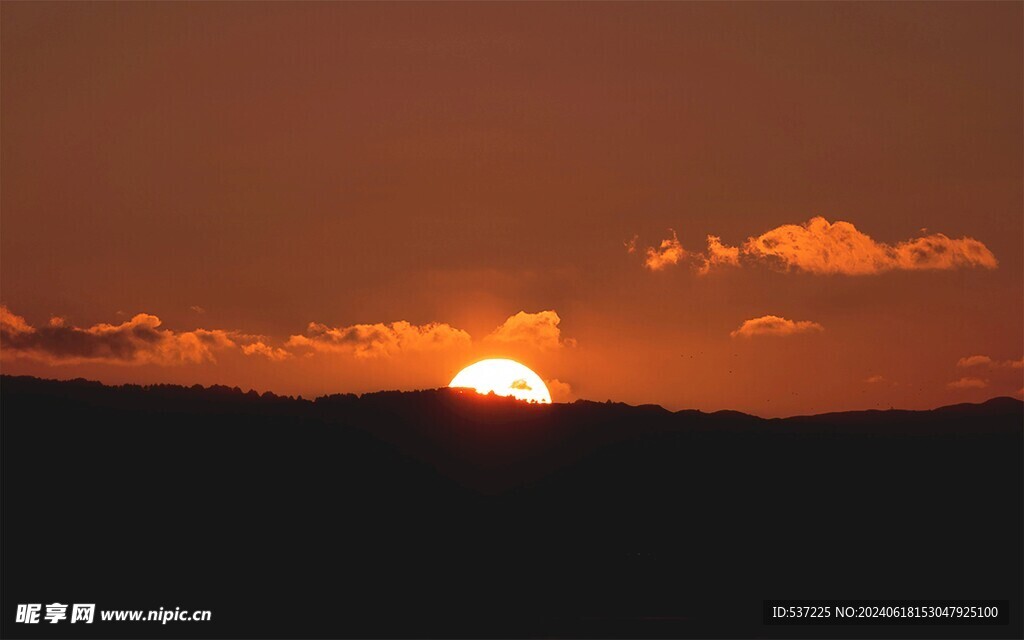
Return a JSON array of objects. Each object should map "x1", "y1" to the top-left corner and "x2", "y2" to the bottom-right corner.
[{"x1": 0, "y1": 2, "x2": 1024, "y2": 416}]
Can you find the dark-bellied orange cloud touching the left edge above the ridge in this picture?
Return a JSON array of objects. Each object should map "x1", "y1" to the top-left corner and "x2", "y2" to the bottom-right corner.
[{"x1": 0, "y1": 306, "x2": 237, "y2": 366}]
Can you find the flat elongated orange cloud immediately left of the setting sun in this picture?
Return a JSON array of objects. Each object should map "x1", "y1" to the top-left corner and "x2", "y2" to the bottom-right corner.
[{"x1": 285, "y1": 321, "x2": 470, "y2": 358}]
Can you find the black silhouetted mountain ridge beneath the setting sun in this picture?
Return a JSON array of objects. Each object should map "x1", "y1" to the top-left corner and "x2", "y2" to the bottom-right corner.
[{"x1": 0, "y1": 377, "x2": 1024, "y2": 638}]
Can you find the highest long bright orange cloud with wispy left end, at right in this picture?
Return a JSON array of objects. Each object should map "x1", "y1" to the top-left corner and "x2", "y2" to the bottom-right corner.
[{"x1": 644, "y1": 216, "x2": 998, "y2": 275}]
